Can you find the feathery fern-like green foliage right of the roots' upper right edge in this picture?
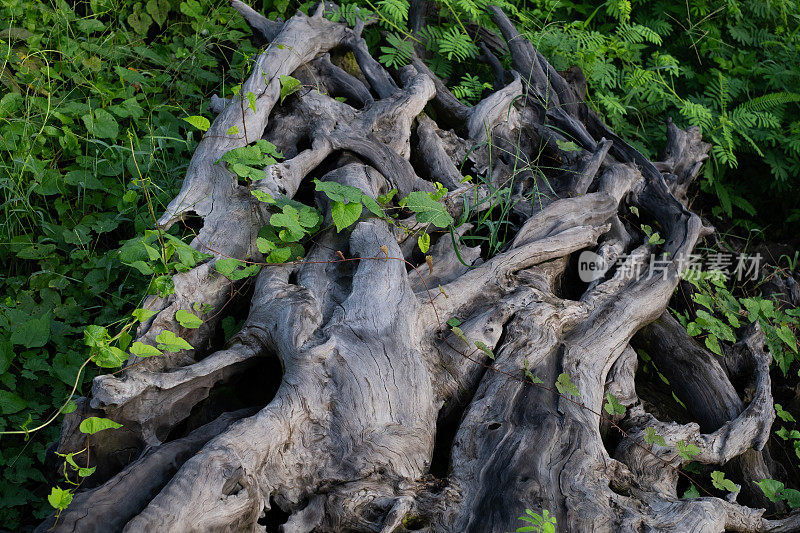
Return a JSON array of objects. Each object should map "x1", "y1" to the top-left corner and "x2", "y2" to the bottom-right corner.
[{"x1": 520, "y1": 0, "x2": 800, "y2": 233}]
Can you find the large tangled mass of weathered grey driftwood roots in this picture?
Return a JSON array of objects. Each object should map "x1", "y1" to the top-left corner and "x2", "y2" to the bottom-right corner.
[{"x1": 42, "y1": 4, "x2": 800, "y2": 532}]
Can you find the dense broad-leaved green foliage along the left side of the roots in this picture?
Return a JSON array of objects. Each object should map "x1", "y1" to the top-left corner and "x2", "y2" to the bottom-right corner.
[{"x1": 0, "y1": 0, "x2": 255, "y2": 530}]
